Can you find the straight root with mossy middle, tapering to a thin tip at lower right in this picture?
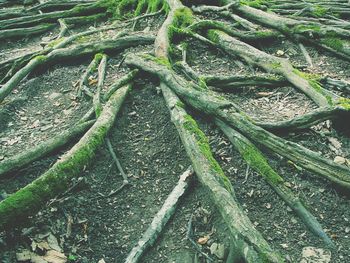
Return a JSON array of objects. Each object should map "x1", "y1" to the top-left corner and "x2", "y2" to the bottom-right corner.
[{"x1": 215, "y1": 119, "x2": 334, "y2": 247}]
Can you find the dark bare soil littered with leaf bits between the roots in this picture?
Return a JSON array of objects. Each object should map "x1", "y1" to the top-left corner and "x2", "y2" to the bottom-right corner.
[{"x1": 0, "y1": 6, "x2": 350, "y2": 263}]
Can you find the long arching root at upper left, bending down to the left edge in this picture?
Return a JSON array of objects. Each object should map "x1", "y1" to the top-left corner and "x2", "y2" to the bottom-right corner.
[{"x1": 0, "y1": 34, "x2": 154, "y2": 102}]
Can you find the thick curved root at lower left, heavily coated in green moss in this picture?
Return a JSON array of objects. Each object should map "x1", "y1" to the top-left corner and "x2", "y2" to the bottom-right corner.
[{"x1": 0, "y1": 86, "x2": 130, "y2": 231}]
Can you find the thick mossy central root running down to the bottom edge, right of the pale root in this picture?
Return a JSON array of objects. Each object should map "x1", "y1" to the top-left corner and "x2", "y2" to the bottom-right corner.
[{"x1": 161, "y1": 84, "x2": 284, "y2": 263}]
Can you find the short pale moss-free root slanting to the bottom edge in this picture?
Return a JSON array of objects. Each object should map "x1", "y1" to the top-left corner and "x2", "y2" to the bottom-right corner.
[{"x1": 124, "y1": 169, "x2": 193, "y2": 263}]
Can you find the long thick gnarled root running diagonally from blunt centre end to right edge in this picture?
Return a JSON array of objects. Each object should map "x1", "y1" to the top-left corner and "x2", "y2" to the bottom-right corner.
[{"x1": 125, "y1": 55, "x2": 350, "y2": 189}]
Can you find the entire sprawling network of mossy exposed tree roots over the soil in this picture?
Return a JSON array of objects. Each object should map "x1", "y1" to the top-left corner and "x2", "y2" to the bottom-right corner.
[{"x1": 0, "y1": 0, "x2": 350, "y2": 263}]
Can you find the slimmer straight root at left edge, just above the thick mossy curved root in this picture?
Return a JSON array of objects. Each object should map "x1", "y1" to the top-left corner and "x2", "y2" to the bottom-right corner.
[{"x1": 0, "y1": 120, "x2": 95, "y2": 178}]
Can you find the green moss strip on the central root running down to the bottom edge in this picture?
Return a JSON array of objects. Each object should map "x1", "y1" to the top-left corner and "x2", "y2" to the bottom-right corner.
[{"x1": 183, "y1": 115, "x2": 233, "y2": 194}]
